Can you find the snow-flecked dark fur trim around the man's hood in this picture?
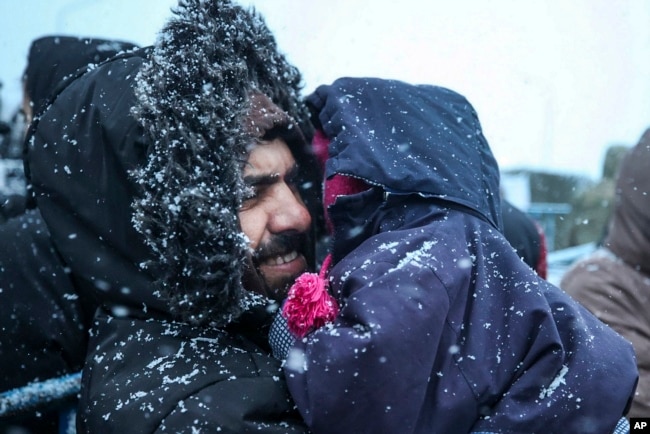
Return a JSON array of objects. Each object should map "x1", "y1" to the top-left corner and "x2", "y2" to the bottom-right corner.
[{"x1": 132, "y1": 0, "x2": 308, "y2": 326}]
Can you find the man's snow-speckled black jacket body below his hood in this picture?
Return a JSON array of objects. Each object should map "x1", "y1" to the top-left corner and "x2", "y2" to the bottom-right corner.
[{"x1": 77, "y1": 306, "x2": 306, "y2": 434}]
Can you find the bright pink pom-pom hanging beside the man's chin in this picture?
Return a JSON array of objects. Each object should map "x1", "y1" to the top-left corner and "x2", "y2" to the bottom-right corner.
[{"x1": 282, "y1": 255, "x2": 339, "y2": 338}]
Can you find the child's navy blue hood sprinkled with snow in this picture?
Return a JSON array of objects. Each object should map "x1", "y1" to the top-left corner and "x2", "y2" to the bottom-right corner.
[{"x1": 307, "y1": 78, "x2": 501, "y2": 228}]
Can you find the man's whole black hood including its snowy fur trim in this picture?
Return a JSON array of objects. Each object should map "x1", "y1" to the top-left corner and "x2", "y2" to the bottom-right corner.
[{"x1": 28, "y1": 0, "x2": 319, "y2": 325}]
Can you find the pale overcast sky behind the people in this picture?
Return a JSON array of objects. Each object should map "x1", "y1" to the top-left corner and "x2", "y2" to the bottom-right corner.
[{"x1": 0, "y1": 0, "x2": 650, "y2": 179}]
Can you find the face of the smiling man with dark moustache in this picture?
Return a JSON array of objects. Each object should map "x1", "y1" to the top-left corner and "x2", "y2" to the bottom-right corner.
[{"x1": 239, "y1": 138, "x2": 311, "y2": 300}]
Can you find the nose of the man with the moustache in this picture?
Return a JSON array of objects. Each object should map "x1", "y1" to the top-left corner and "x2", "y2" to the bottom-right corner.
[{"x1": 269, "y1": 184, "x2": 311, "y2": 233}]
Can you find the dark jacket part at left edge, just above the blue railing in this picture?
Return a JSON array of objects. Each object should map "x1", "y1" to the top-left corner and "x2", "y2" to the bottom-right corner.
[{"x1": 0, "y1": 209, "x2": 93, "y2": 392}]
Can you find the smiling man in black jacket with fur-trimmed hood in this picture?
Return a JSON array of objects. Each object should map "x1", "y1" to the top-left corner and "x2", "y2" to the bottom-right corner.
[{"x1": 11, "y1": 0, "x2": 321, "y2": 433}]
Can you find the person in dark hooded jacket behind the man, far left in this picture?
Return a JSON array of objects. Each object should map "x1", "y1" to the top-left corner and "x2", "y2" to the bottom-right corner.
[{"x1": 0, "y1": 36, "x2": 136, "y2": 432}]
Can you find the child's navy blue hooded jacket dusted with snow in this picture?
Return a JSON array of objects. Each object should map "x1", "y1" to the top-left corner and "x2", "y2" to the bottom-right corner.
[{"x1": 285, "y1": 78, "x2": 637, "y2": 434}]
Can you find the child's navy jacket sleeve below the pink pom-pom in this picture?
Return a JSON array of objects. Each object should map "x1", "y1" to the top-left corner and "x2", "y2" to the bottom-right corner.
[{"x1": 285, "y1": 262, "x2": 449, "y2": 433}]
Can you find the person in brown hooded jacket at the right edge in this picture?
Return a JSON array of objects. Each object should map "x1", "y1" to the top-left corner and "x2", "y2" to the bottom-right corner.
[{"x1": 560, "y1": 130, "x2": 650, "y2": 417}]
